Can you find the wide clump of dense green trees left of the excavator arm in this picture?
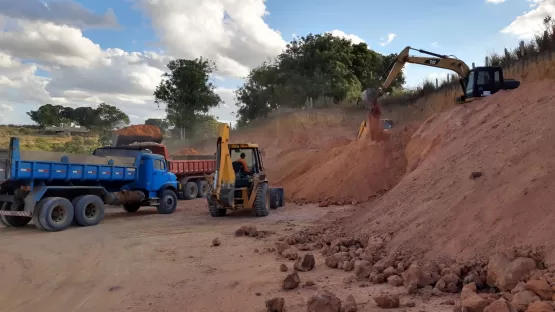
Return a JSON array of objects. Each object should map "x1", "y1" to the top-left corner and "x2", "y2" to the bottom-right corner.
[{"x1": 235, "y1": 33, "x2": 404, "y2": 127}]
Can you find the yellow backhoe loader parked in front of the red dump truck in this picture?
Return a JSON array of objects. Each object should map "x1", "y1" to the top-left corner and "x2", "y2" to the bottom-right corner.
[{"x1": 206, "y1": 123, "x2": 285, "y2": 217}]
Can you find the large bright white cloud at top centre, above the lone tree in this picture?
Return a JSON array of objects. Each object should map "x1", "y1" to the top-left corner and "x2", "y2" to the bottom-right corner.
[{"x1": 139, "y1": 0, "x2": 286, "y2": 77}]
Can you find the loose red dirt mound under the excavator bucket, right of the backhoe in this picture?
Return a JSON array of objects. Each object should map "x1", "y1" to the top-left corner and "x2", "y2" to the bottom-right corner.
[{"x1": 272, "y1": 127, "x2": 413, "y2": 205}]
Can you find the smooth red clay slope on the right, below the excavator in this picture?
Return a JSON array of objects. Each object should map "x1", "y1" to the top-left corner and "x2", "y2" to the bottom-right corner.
[{"x1": 330, "y1": 80, "x2": 555, "y2": 263}]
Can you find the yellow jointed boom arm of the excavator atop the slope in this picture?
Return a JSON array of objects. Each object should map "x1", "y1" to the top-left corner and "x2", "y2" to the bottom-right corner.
[{"x1": 375, "y1": 47, "x2": 470, "y2": 101}]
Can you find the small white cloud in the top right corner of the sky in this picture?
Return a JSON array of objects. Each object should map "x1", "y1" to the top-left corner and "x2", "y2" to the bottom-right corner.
[{"x1": 501, "y1": 0, "x2": 555, "y2": 39}]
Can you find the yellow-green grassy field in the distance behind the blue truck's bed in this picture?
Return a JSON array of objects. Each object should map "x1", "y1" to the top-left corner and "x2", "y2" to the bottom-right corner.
[{"x1": 0, "y1": 126, "x2": 99, "y2": 153}]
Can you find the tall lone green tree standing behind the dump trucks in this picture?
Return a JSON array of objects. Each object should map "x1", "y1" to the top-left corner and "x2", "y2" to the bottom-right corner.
[{"x1": 154, "y1": 58, "x2": 222, "y2": 139}]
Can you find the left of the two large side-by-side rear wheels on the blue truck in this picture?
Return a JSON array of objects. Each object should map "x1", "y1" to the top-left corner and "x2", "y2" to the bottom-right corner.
[{"x1": 35, "y1": 197, "x2": 75, "y2": 232}]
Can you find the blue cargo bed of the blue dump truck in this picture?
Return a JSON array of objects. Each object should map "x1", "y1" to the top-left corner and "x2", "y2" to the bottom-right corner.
[{"x1": 0, "y1": 144, "x2": 137, "y2": 183}]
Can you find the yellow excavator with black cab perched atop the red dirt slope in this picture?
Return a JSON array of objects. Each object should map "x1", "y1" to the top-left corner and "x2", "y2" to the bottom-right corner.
[{"x1": 358, "y1": 47, "x2": 520, "y2": 138}]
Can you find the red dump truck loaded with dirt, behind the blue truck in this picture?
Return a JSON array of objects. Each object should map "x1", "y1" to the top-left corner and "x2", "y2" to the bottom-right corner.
[{"x1": 106, "y1": 136, "x2": 216, "y2": 199}]
